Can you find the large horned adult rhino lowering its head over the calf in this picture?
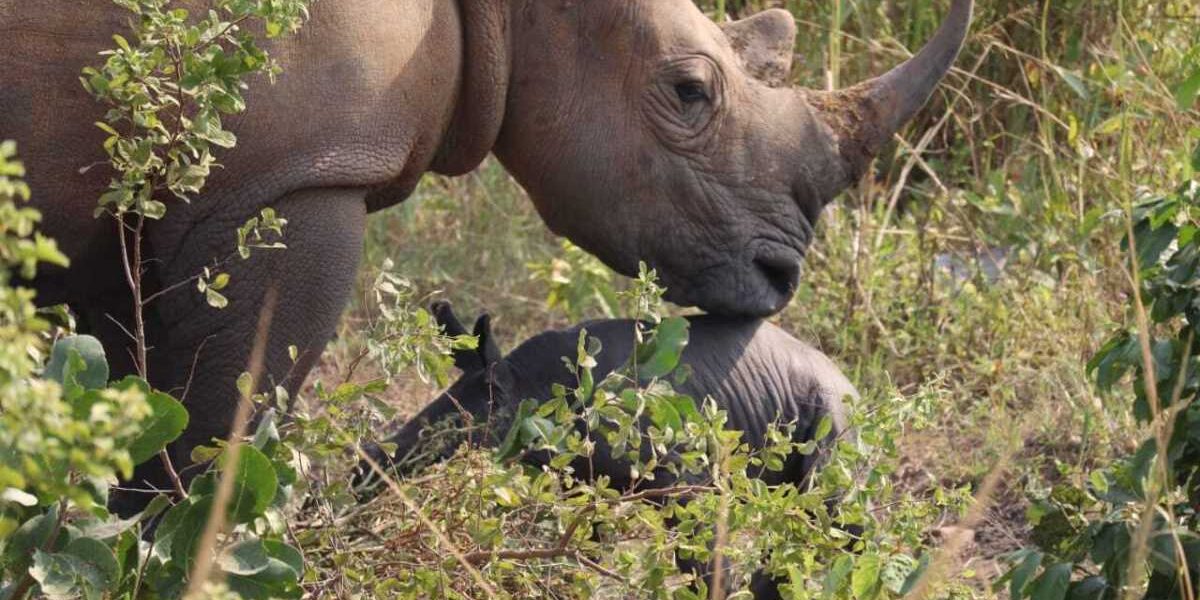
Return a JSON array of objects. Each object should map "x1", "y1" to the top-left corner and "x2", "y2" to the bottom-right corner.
[{"x1": 0, "y1": 0, "x2": 972, "y2": 499}]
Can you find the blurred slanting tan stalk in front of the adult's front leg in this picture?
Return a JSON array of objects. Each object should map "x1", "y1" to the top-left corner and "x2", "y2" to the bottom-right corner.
[{"x1": 184, "y1": 286, "x2": 278, "y2": 599}]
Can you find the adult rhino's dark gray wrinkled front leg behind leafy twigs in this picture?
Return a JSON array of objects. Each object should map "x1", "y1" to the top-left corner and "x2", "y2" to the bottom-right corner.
[{"x1": 119, "y1": 188, "x2": 366, "y2": 513}]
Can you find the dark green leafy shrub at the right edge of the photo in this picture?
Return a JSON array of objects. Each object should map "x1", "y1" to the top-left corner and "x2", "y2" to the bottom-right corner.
[{"x1": 998, "y1": 148, "x2": 1200, "y2": 599}]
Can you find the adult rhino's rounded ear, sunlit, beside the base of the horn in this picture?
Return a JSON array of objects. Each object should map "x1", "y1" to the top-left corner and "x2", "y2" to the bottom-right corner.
[{"x1": 721, "y1": 8, "x2": 796, "y2": 86}]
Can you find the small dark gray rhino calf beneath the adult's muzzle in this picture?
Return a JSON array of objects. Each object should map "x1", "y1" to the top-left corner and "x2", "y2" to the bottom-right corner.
[{"x1": 369, "y1": 304, "x2": 858, "y2": 600}]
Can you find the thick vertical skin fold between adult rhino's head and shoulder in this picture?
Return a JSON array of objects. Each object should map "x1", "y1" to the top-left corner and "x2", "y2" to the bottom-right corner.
[{"x1": 432, "y1": 0, "x2": 511, "y2": 175}]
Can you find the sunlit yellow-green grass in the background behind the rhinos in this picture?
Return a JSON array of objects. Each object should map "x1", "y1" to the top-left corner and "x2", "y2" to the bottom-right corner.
[{"x1": 302, "y1": 0, "x2": 1200, "y2": 593}]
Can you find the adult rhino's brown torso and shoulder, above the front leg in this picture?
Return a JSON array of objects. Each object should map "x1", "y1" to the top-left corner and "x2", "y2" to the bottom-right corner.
[{"x1": 0, "y1": 0, "x2": 462, "y2": 296}]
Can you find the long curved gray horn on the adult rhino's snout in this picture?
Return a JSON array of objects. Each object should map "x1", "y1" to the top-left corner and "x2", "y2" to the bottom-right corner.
[{"x1": 808, "y1": 0, "x2": 974, "y2": 182}]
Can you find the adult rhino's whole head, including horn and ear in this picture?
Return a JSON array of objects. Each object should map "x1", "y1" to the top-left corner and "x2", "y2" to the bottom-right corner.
[{"x1": 437, "y1": 0, "x2": 973, "y2": 316}]
